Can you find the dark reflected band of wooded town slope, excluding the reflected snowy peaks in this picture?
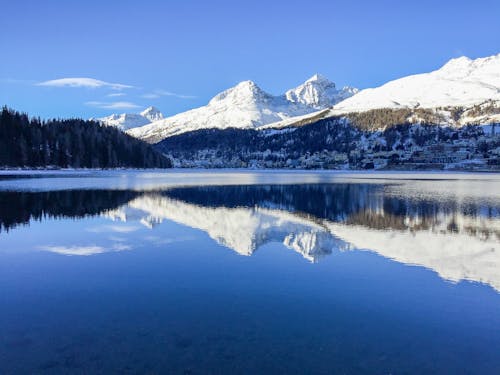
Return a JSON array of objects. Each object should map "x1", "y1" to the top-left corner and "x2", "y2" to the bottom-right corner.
[{"x1": 164, "y1": 182, "x2": 500, "y2": 239}]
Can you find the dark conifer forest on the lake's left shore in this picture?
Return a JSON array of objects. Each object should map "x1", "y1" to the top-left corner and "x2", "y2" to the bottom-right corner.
[{"x1": 0, "y1": 107, "x2": 171, "y2": 168}]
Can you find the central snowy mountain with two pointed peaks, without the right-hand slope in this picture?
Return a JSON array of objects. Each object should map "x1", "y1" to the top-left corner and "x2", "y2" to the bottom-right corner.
[{"x1": 129, "y1": 75, "x2": 356, "y2": 143}]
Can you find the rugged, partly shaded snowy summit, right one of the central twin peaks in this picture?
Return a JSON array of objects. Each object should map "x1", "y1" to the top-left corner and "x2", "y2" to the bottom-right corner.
[{"x1": 285, "y1": 74, "x2": 359, "y2": 109}]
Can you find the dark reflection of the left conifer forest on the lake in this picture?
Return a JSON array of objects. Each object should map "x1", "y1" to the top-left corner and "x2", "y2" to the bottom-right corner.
[{"x1": 0, "y1": 190, "x2": 139, "y2": 232}]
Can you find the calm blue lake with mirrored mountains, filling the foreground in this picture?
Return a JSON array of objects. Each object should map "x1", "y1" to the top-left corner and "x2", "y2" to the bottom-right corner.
[{"x1": 0, "y1": 171, "x2": 500, "y2": 374}]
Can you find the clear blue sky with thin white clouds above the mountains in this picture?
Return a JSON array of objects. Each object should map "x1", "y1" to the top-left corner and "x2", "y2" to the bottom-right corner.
[{"x1": 0, "y1": 0, "x2": 500, "y2": 117}]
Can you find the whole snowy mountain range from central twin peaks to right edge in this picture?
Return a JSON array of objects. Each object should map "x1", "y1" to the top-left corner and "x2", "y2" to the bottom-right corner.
[{"x1": 129, "y1": 54, "x2": 500, "y2": 143}]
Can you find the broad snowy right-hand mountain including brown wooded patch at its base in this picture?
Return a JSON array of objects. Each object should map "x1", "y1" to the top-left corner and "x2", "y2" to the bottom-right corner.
[{"x1": 261, "y1": 54, "x2": 500, "y2": 130}]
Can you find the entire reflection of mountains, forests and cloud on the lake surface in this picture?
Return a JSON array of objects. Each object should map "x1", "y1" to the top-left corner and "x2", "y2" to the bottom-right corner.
[{"x1": 0, "y1": 181, "x2": 500, "y2": 290}]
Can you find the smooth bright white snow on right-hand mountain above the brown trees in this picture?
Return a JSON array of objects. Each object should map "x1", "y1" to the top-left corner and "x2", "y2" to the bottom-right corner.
[{"x1": 334, "y1": 54, "x2": 500, "y2": 114}]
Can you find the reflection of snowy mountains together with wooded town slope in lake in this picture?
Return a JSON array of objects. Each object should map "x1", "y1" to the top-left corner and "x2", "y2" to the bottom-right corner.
[{"x1": 139, "y1": 184, "x2": 500, "y2": 290}]
